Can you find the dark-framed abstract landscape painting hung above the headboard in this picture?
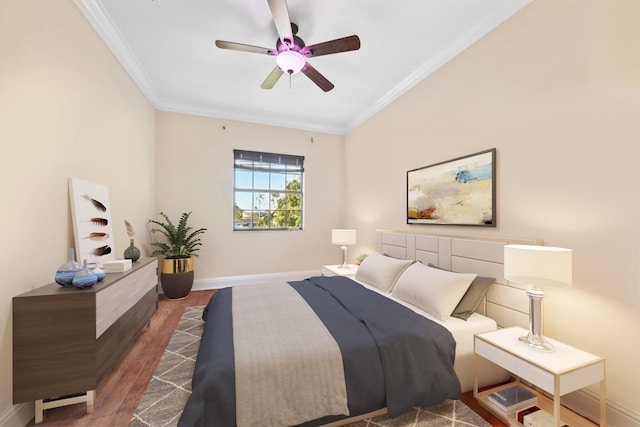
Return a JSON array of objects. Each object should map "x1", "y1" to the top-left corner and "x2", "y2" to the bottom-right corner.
[{"x1": 407, "y1": 148, "x2": 496, "y2": 227}]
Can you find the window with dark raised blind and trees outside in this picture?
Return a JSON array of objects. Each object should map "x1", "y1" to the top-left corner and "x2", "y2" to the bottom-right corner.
[{"x1": 233, "y1": 150, "x2": 304, "y2": 231}]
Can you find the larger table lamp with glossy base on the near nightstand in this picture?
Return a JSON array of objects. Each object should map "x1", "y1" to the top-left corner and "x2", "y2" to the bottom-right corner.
[{"x1": 504, "y1": 245, "x2": 571, "y2": 352}]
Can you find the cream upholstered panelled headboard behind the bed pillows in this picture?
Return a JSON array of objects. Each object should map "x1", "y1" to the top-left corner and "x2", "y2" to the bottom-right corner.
[{"x1": 376, "y1": 230, "x2": 543, "y2": 328}]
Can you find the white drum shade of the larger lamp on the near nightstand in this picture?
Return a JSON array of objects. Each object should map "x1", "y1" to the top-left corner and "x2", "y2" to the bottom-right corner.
[{"x1": 504, "y1": 245, "x2": 572, "y2": 287}]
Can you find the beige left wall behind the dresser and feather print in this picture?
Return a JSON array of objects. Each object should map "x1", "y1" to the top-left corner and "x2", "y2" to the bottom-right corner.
[{"x1": 0, "y1": 0, "x2": 155, "y2": 425}]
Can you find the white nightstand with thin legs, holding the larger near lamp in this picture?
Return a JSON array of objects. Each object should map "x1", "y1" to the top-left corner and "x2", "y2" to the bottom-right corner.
[{"x1": 473, "y1": 327, "x2": 606, "y2": 427}]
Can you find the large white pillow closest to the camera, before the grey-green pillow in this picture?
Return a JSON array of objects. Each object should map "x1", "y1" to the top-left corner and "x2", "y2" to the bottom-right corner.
[{"x1": 391, "y1": 263, "x2": 476, "y2": 320}]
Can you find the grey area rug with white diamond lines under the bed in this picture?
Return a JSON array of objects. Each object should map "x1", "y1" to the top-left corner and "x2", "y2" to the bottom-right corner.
[{"x1": 129, "y1": 306, "x2": 491, "y2": 427}]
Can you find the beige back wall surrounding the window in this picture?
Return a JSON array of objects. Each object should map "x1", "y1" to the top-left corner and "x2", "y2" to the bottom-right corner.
[{"x1": 156, "y1": 112, "x2": 344, "y2": 279}]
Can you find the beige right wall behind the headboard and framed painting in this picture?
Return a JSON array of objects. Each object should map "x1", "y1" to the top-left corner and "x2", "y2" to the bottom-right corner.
[{"x1": 346, "y1": 0, "x2": 640, "y2": 414}]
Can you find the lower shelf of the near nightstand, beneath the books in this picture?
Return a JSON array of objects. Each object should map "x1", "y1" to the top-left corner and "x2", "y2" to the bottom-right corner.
[{"x1": 474, "y1": 381, "x2": 597, "y2": 427}]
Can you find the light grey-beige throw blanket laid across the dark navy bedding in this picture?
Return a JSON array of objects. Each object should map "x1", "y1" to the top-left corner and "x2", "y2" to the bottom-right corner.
[{"x1": 232, "y1": 283, "x2": 349, "y2": 427}]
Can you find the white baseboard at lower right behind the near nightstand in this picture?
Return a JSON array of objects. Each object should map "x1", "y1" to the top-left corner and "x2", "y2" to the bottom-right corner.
[{"x1": 562, "y1": 388, "x2": 640, "y2": 427}]
